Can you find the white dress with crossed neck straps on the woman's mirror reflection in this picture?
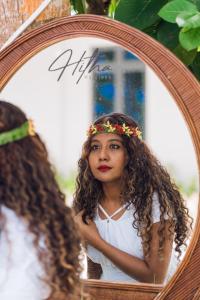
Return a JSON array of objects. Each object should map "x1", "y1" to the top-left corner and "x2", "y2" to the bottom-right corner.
[{"x1": 87, "y1": 194, "x2": 178, "y2": 283}]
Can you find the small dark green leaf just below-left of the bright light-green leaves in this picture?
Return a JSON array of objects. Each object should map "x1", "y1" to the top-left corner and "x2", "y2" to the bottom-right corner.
[{"x1": 157, "y1": 21, "x2": 180, "y2": 50}]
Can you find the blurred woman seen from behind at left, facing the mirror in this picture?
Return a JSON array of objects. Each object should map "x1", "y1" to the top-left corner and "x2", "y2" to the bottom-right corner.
[{"x1": 0, "y1": 101, "x2": 81, "y2": 300}]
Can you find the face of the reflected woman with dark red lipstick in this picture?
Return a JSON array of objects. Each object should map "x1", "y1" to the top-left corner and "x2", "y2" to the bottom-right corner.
[{"x1": 88, "y1": 133, "x2": 128, "y2": 183}]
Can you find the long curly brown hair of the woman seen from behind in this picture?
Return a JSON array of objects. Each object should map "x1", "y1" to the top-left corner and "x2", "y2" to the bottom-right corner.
[{"x1": 0, "y1": 101, "x2": 82, "y2": 300}]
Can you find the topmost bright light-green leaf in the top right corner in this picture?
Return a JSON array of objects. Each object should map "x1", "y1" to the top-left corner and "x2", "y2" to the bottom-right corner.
[{"x1": 158, "y1": 0, "x2": 198, "y2": 23}]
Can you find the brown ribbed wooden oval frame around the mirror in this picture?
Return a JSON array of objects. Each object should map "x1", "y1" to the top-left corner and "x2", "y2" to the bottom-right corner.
[{"x1": 0, "y1": 15, "x2": 200, "y2": 300}]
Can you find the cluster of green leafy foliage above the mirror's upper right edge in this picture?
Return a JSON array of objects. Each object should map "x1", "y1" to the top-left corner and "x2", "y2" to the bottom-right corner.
[{"x1": 70, "y1": 0, "x2": 200, "y2": 80}]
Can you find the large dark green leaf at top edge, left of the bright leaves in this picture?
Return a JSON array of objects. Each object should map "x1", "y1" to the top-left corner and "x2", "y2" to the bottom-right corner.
[{"x1": 115, "y1": 0, "x2": 167, "y2": 30}]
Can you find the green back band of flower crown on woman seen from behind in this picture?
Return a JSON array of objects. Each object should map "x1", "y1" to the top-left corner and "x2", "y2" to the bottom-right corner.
[{"x1": 0, "y1": 120, "x2": 35, "y2": 146}]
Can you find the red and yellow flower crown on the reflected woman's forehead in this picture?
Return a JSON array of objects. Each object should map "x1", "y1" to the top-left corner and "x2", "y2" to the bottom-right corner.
[{"x1": 88, "y1": 121, "x2": 142, "y2": 139}]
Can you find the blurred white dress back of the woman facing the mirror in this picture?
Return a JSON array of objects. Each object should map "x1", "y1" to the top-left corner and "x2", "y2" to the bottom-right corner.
[{"x1": 0, "y1": 206, "x2": 49, "y2": 300}]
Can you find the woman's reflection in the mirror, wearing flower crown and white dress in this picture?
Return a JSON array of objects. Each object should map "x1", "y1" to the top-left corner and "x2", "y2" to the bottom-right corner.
[{"x1": 74, "y1": 113, "x2": 190, "y2": 283}]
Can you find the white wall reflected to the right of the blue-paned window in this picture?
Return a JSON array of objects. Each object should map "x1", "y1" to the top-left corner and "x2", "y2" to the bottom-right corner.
[{"x1": 146, "y1": 68, "x2": 198, "y2": 180}]
